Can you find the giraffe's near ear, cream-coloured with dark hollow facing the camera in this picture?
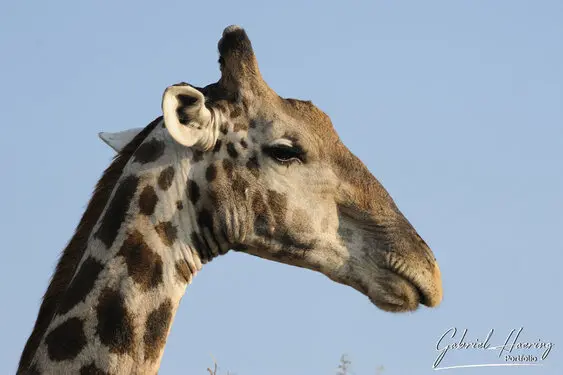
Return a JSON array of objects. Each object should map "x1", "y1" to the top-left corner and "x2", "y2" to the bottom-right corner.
[{"x1": 162, "y1": 83, "x2": 217, "y2": 150}]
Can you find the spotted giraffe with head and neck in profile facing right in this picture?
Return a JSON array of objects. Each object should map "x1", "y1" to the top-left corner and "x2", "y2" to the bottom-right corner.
[{"x1": 18, "y1": 26, "x2": 442, "y2": 375}]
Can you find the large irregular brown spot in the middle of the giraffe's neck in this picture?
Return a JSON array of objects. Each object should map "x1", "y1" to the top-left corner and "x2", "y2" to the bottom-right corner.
[{"x1": 117, "y1": 230, "x2": 163, "y2": 290}]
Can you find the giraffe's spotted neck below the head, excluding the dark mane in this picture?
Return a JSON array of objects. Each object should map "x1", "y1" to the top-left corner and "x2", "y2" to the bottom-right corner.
[{"x1": 20, "y1": 118, "x2": 228, "y2": 374}]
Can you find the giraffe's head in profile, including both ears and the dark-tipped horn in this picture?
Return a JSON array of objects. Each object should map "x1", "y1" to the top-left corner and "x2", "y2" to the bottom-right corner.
[{"x1": 103, "y1": 26, "x2": 442, "y2": 312}]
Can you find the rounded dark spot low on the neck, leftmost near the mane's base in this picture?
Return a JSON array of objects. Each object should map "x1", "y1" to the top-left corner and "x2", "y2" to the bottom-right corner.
[{"x1": 45, "y1": 318, "x2": 86, "y2": 362}]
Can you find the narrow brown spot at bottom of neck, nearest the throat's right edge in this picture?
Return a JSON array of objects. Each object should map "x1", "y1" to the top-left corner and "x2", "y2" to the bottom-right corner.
[{"x1": 143, "y1": 299, "x2": 172, "y2": 360}]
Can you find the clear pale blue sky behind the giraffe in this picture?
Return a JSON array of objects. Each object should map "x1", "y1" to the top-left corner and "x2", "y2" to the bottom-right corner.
[{"x1": 0, "y1": 0, "x2": 563, "y2": 375}]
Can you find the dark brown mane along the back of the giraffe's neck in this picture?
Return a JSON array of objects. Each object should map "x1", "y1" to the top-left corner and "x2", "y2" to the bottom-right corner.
[{"x1": 18, "y1": 116, "x2": 162, "y2": 373}]
